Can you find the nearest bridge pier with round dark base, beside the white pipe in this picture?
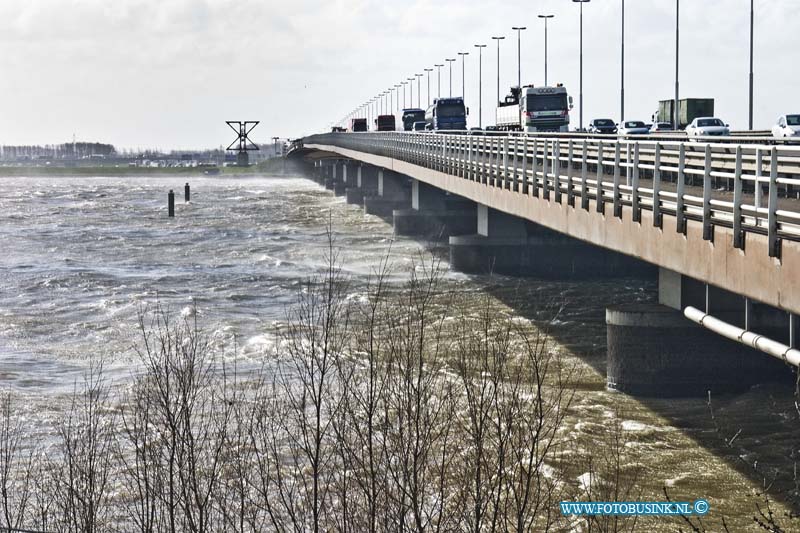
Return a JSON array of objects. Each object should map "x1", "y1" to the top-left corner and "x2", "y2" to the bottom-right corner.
[{"x1": 606, "y1": 268, "x2": 790, "y2": 397}]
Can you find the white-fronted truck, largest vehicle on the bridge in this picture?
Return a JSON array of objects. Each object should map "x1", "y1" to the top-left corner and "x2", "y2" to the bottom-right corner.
[{"x1": 495, "y1": 83, "x2": 572, "y2": 132}]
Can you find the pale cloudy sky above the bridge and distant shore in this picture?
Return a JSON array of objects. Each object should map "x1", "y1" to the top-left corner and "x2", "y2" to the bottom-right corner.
[{"x1": 0, "y1": 0, "x2": 800, "y2": 149}]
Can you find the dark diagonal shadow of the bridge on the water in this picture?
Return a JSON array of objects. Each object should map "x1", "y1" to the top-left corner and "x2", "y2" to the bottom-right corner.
[{"x1": 428, "y1": 241, "x2": 800, "y2": 518}]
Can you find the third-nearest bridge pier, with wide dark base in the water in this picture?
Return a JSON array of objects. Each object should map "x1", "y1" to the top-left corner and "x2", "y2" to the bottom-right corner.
[{"x1": 392, "y1": 180, "x2": 477, "y2": 239}]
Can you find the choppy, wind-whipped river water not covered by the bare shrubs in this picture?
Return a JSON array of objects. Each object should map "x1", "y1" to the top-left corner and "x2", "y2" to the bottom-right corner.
[{"x1": 0, "y1": 170, "x2": 800, "y2": 531}]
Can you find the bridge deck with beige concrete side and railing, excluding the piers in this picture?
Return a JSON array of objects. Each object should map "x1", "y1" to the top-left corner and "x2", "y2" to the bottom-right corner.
[{"x1": 304, "y1": 133, "x2": 800, "y2": 314}]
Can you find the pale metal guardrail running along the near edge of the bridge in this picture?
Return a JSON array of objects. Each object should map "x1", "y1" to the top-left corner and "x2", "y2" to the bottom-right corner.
[{"x1": 304, "y1": 132, "x2": 800, "y2": 257}]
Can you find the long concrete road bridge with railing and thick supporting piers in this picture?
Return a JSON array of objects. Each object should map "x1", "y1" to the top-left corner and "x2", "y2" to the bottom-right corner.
[{"x1": 292, "y1": 132, "x2": 800, "y2": 395}]
